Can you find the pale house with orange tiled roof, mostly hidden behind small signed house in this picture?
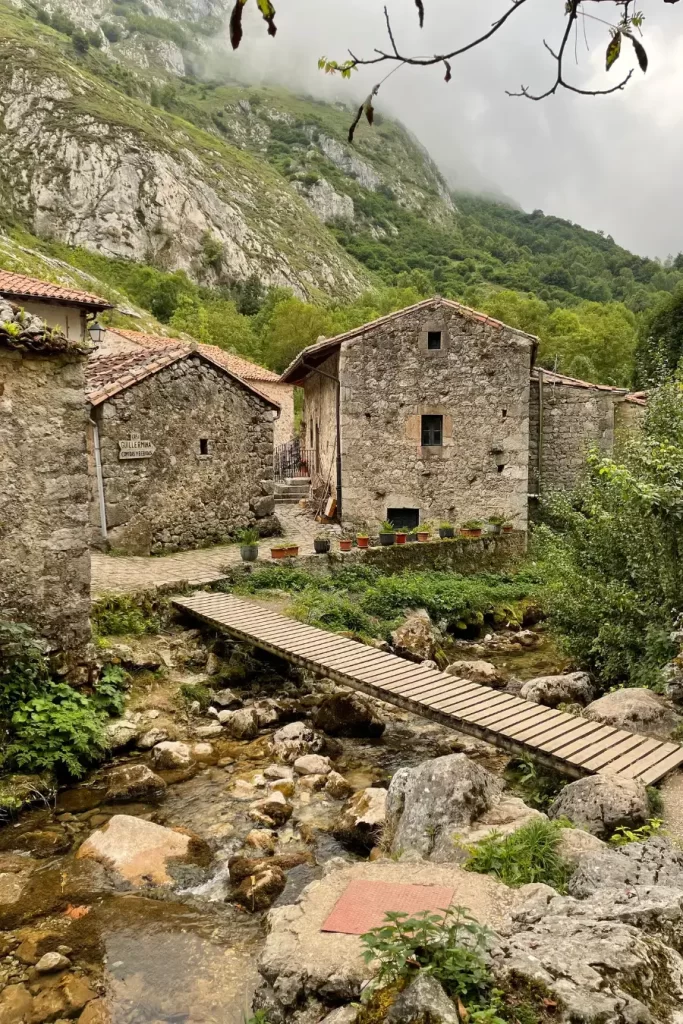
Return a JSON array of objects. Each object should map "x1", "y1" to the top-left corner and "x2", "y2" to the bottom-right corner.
[{"x1": 98, "y1": 328, "x2": 294, "y2": 446}]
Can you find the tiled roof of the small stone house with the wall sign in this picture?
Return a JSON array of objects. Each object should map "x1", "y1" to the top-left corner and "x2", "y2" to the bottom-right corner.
[{"x1": 85, "y1": 345, "x2": 280, "y2": 410}]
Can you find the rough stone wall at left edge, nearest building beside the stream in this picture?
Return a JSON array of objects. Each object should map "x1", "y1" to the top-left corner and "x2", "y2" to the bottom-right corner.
[{"x1": 0, "y1": 342, "x2": 90, "y2": 659}]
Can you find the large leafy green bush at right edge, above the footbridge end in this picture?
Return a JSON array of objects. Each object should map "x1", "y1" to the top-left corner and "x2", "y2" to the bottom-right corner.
[{"x1": 536, "y1": 381, "x2": 683, "y2": 688}]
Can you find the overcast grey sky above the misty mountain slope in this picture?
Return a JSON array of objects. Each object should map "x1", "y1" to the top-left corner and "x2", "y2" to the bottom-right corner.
[{"x1": 214, "y1": 0, "x2": 683, "y2": 258}]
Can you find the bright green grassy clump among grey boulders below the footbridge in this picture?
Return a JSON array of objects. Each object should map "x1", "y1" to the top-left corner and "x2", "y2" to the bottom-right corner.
[{"x1": 465, "y1": 818, "x2": 571, "y2": 892}]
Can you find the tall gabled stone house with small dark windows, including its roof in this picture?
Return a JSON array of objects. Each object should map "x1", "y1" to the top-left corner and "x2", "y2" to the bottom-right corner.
[{"x1": 283, "y1": 298, "x2": 537, "y2": 528}]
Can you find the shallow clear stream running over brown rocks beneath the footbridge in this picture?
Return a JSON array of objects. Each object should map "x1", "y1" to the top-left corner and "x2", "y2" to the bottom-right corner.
[{"x1": 0, "y1": 640, "x2": 562, "y2": 1024}]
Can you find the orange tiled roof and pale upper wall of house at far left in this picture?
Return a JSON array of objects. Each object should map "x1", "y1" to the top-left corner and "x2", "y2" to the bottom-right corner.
[{"x1": 0, "y1": 270, "x2": 113, "y2": 342}]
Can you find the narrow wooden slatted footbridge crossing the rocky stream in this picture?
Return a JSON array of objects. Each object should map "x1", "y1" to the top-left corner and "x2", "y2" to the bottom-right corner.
[{"x1": 174, "y1": 593, "x2": 683, "y2": 785}]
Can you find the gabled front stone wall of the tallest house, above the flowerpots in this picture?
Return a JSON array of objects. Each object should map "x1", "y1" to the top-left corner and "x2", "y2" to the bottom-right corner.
[{"x1": 340, "y1": 306, "x2": 531, "y2": 529}]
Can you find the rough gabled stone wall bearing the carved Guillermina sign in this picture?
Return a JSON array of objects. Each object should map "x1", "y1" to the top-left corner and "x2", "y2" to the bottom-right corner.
[{"x1": 92, "y1": 355, "x2": 276, "y2": 554}]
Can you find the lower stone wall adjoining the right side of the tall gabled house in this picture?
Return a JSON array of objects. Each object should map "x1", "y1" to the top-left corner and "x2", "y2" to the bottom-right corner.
[{"x1": 528, "y1": 381, "x2": 621, "y2": 495}]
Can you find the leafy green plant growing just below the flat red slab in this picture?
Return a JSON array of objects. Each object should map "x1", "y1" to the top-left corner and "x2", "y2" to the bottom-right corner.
[{"x1": 360, "y1": 906, "x2": 494, "y2": 1009}]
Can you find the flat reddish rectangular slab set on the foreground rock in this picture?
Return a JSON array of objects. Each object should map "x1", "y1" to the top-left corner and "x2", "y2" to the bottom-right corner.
[{"x1": 321, "y1": 879, "x2": 455, "y2": 935}]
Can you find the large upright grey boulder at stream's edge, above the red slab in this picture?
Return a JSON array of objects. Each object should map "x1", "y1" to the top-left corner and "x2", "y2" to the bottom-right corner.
[{"x1": 384, "y1": 754, "x2": 503, "y2": 860}]
